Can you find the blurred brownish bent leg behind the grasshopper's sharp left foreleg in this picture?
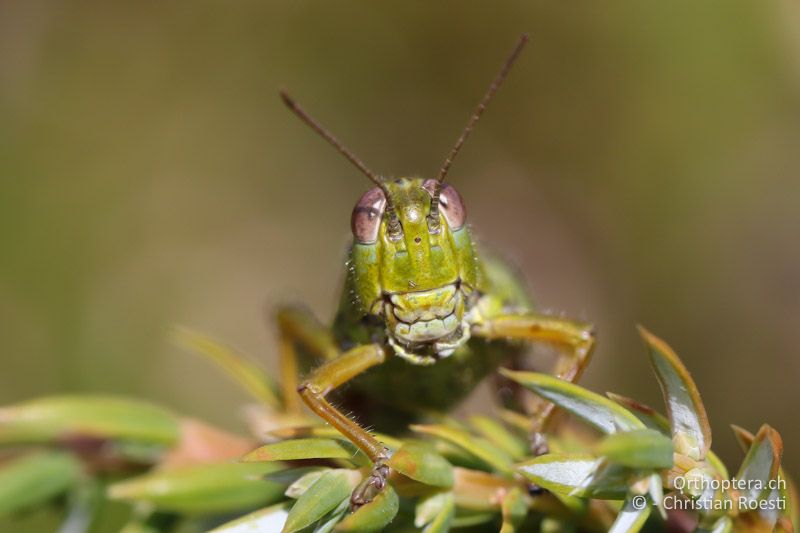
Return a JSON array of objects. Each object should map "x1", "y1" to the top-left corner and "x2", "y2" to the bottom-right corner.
[{"x1": 275, "y1": 306, "x2": 340, "y2": 414}]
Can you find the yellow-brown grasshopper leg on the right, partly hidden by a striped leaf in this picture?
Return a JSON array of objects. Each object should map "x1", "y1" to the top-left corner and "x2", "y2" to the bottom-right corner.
[{"x1": 473, "y1": 313, "x2": 594, "y2": 455}]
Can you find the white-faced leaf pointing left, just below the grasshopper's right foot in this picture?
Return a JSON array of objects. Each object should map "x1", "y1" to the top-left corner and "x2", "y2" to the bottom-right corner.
[{"x1": 517, "y1": 453, "x2": 631, "y2": 500}]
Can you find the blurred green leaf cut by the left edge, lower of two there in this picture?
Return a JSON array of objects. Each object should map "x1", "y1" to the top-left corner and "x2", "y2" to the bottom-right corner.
[{"x1": 0, "y1": 452, "x2": 81, "y2": 516}]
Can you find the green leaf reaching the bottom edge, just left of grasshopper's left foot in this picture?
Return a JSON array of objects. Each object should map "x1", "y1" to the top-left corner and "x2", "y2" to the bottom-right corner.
[{"x1": 283, "y1": 469, "x2": 360, "y2": 533}]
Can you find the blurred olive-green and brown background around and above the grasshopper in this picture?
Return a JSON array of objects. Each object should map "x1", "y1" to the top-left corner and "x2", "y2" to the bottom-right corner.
[{"x1": 0, "y1": 0, "x2": 800, "y2": 471}]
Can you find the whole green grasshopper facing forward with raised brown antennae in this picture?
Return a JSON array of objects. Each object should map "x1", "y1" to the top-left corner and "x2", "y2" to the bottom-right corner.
[{"x1": 277, "y1": 35, "x2": 594, "y2": 507}]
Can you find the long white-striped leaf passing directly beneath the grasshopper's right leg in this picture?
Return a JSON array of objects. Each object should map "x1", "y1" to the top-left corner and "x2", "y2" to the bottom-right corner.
[{"x1": 500, "y1": 368, "x2": 645, "y2": 434}]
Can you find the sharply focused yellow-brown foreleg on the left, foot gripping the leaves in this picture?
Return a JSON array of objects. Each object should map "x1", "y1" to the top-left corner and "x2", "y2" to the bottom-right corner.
[{"x1": 297, "y1": 344, "x2": 389, "y2": 509}]
